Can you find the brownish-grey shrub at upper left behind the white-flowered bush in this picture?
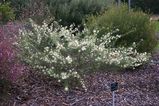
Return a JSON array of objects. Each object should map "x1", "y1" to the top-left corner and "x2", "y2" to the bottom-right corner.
[{"x1": 5, "y1": 0, "x2": 49, "y2": 23}]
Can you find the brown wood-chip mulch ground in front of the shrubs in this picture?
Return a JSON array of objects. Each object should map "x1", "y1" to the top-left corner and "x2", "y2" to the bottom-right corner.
[{"x1": 0, "y1": 54, "x2": 159, "y2": 106}]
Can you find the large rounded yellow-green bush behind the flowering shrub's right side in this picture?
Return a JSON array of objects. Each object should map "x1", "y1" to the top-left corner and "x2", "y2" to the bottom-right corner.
[{"x1": 87, "y1": 5, "x2": 157, "y2": 52}]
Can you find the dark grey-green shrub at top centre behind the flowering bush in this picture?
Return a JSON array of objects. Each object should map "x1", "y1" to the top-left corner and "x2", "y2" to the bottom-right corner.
[{"x1": 48, "y1": 0, "x2": 112, "y2": 26}]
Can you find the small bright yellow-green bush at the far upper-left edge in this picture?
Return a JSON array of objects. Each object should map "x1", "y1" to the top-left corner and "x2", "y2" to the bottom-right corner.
[{"x1": 0, "y1": 3, "x2": 15, "y2": 24}]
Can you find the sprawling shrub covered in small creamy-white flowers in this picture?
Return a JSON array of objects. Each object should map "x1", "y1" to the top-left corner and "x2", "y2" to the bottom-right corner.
[{"x1": 16, "y1": 22, "x2": 149, "y2": 90}]
